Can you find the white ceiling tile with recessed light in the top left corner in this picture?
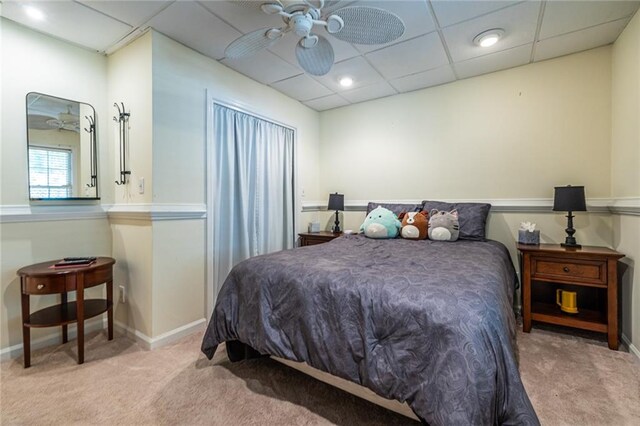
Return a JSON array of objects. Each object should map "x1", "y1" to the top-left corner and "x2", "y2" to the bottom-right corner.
[{"x1": 2, "y1": 1, "x2": 133, "y2": 51}]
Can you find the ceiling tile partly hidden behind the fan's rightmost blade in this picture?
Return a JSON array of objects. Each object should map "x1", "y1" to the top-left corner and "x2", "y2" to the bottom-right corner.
[{"x1": 353, "y1": 0, "x2": 436, "y2": 53}]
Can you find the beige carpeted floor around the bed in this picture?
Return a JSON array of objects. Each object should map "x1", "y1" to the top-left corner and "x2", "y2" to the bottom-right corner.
[{"x1": 0, "y1": 328, "x2": 640, "y2": 426}]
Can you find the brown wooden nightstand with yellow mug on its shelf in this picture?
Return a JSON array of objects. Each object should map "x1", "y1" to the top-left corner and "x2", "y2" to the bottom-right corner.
[{"x1": 517, "y1": 244, "x2": 624, "y2": 349}]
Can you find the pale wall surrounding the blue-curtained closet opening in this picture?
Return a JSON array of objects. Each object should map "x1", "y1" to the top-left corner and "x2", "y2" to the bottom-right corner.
[{"x1": 153, "y1": 32, "x2": 319, "y2": 322}]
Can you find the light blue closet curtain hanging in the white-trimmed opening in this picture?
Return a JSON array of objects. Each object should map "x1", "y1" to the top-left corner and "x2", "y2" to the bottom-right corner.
[{"x1": 212, "y1": 104, "x2": 294, "y2": 295}]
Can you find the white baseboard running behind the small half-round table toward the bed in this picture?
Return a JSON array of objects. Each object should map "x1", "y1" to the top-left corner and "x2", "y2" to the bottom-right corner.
[{"x1": 0, "y1": 318, "x2": 207, "y2": 361}]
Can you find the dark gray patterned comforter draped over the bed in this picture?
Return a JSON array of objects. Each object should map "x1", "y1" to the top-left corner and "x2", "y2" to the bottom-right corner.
[{"x1": 202, "y1": 235, "x2": 539, "y2": 425}]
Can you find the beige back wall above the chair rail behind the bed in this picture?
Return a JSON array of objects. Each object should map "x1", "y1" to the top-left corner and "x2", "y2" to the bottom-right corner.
[{"x1": 320, "y1": 47, "x2": 611, "y2": 201}]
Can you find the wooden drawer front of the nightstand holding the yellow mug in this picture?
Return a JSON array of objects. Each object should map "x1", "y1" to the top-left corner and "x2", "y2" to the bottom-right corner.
[{"x1": 531, "y1": 257, "x2": 607, "y2": 286}]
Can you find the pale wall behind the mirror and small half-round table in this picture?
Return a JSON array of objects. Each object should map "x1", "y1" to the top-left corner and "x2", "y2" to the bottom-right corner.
[{"x1": 0, "y1": 18, "x2": 111, "y2": 350}]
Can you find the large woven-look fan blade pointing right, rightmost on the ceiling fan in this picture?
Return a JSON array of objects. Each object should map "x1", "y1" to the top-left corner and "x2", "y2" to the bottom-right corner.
[{"x1": 332, "y1": 6, "x2": 404, "y2": 44}]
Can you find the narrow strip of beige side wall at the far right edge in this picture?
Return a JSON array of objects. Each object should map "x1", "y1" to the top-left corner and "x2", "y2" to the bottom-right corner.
[{"x1": 611, "y1": 13, "x2": 640, "y2": 356}]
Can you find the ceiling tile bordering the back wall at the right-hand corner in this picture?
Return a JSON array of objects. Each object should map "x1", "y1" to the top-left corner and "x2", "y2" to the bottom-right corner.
[{"x1": 534, "y1": 18, "x2": 631, "y2": 61}]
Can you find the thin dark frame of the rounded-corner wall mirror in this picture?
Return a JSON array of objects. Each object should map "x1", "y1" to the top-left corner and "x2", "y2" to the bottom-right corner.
[{"x1": 25, "y1": 92, "x2": 100, "y2": 201}]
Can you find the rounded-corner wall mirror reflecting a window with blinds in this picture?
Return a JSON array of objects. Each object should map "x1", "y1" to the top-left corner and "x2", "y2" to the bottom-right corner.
[{"x1": 27, "y1": 92, "x2": 99, "y2": 200}]
